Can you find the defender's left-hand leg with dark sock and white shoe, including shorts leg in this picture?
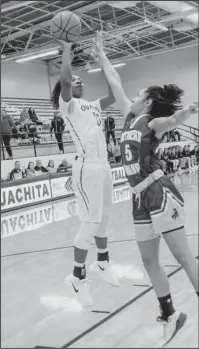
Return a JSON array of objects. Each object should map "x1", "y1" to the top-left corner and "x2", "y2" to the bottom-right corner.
[{"x1": 133, "y1": 181, "x2": 186, "y2": 343}]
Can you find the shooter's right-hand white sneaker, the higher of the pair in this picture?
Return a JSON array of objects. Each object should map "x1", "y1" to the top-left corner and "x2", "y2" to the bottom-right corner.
[{"x1": 89, "y1": 261, "x2": 120, "y2": 286}]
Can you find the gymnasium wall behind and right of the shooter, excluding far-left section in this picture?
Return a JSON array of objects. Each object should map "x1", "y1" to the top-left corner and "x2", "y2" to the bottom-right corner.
[{"x1": 51, "y1": 47, "x2": 198, "y2": 127}]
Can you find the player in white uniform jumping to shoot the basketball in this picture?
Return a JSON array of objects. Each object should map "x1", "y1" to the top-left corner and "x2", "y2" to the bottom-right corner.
[{"x1": 51, "y1": 42, "x2": 119, "y2": 305}]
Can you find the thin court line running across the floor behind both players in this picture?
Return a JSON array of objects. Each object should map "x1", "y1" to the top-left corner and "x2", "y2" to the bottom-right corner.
[{"x1": 1, "y1": 233, "x2": 198, "y2": 258}]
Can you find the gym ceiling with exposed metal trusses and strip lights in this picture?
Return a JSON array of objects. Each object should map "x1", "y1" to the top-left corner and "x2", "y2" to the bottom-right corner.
[{"x1": 1, "y1": 0, "x2": 198, "y2": 75}]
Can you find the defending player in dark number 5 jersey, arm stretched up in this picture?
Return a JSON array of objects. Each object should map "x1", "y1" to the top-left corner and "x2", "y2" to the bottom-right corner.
[{"x1": 94, "y1": 33, "x2": 198, "y2": 344}]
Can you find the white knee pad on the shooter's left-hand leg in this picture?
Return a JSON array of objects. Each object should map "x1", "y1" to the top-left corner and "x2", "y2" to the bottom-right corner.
[{"x1": 74, "y1": 222, "x2": 100, "y2": 250}]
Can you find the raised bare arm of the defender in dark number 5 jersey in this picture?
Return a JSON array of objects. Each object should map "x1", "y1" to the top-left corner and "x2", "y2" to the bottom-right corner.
[{"x1": 92, "y1": 32, "x2": 131, "y2": 116}]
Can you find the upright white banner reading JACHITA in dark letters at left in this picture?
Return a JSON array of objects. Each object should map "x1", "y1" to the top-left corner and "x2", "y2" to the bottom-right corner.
[{"x1": 1, "y1": 180, "x2": 51, "y2": 211}]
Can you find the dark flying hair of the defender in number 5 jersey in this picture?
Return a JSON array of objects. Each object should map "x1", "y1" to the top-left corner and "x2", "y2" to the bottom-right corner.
[{"x1": 146, "y1": 84, "x2": 184, "y2": 118}]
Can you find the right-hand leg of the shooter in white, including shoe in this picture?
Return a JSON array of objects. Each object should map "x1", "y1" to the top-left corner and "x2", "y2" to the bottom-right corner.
[{"x1": 90, "y1": 164, "x2": 119, "y2": 286}]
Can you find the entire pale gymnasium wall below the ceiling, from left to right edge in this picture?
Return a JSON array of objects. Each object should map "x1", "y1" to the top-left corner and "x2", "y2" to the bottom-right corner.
[{"x1": 1, "y1": 47, "x2": 198, "y2": 127}]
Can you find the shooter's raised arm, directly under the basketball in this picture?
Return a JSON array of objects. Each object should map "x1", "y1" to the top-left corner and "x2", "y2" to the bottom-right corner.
[{"x1": 59, "y1": 40, "x2": 72, "y2": 102}]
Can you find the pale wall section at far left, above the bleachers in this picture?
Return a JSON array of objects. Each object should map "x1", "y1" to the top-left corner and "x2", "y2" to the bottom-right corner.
[{"x1": 1, "y1": 61, "x2": 50, "y2": 99}]
